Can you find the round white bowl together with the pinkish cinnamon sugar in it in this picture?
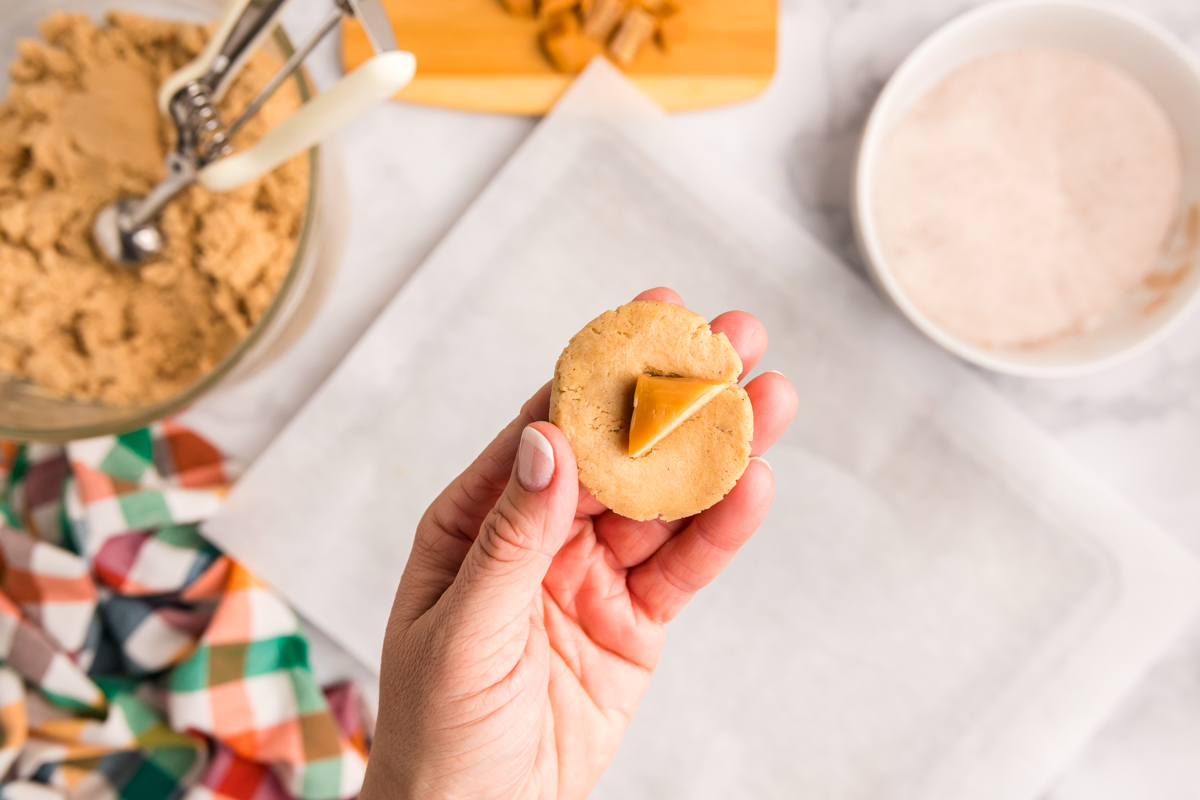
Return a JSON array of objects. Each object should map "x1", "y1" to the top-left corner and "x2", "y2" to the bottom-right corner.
[{"x1": 854, "y1": 0, "x2": 1200, "y2": 378}]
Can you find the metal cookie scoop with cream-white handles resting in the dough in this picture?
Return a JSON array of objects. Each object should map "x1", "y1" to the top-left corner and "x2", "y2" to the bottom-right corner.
[{"x1": 92, "y1": 0, "x2": 416, "y2": 269}]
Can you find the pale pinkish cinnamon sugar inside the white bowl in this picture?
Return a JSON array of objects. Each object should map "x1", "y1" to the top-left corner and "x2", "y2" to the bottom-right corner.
[{"x1": 876, "y1": 50, "x2": 1182, "y2": 348}]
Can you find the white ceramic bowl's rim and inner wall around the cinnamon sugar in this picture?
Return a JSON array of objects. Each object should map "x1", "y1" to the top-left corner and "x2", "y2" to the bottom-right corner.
[{"x1": 854, "y1": 0, "x2": 1200, "y2": 378}]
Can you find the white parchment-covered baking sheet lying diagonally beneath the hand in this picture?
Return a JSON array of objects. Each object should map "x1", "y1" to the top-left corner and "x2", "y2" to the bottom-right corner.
[{"x1": 206, "y1": 62, "x2": 1200, "y2": 800}]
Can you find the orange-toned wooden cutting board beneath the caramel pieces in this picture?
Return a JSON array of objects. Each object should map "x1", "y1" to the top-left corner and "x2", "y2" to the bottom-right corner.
[{"x1": 342, "y1": 0, "x2": 778, "y2": 114}]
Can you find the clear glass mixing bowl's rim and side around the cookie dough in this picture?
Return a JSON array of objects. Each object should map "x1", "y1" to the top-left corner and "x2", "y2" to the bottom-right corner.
[{"x1": 0, "y1": 0, "x2": 336, "y2": 441}]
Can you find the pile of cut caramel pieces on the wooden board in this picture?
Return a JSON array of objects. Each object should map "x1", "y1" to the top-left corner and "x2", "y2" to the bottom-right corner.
[{"x1": 500, "y1": 0, "x2": 685, "y2": 72}]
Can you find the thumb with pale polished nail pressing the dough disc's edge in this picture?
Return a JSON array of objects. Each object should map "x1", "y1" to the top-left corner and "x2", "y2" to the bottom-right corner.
[{"x1": 455, "y1": 422, "x2": 580, "y2": 625}]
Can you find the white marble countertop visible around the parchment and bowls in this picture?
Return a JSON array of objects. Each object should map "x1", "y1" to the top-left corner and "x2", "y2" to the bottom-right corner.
[{"x1": 182, "y1": 0, "x2": 1200, "y2": 800}]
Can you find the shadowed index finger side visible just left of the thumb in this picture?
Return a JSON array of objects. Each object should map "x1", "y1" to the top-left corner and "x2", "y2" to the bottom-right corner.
[{"x1": 392, "y1": 384, "x2": 550, "y2": 624}]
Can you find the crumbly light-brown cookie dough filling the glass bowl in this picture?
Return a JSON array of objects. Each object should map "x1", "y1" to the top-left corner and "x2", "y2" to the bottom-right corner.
[{"x1": 0, "y1": 13, "x2": 308, "y2": 405}]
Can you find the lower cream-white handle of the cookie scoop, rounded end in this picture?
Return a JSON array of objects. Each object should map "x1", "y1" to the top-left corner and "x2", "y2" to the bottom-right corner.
[{"x1": 197, "y1": 50, "x2": 416, "y2": 192}]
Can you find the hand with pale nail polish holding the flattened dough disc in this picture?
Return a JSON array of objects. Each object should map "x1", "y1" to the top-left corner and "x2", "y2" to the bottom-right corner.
[{"x1": 361, "y1": 289, "x2": 798, "y2": 800}]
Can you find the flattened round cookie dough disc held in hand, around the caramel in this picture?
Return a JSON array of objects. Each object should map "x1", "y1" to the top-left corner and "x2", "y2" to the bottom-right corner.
[{"x1": 550, "y1": 302, "x2": 754, "y2": 521}]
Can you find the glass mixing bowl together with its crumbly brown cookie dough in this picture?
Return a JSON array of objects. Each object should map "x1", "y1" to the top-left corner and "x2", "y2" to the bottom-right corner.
[{"x1": 0, "y1": 0, "x2": 328, "y2": 441}]
